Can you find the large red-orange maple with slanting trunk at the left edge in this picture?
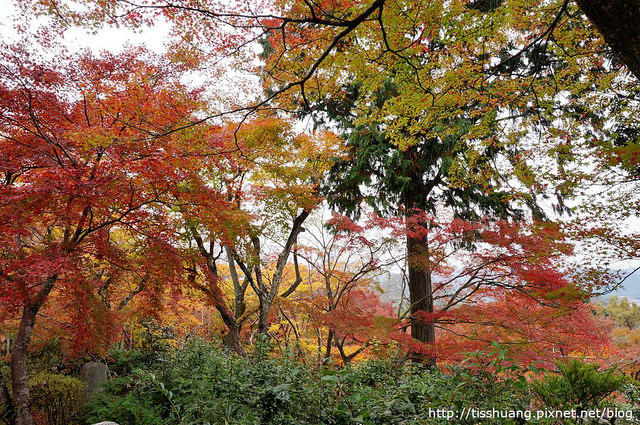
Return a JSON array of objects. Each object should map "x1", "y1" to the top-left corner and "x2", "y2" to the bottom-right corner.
[{"x1": 0, "y1": 44, "x2": 226, "y2": 425}]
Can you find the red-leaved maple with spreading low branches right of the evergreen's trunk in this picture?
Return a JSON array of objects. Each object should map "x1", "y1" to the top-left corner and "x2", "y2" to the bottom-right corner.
[{"x1": 376, "y1": 213, "x2": 607, "y2": 363}]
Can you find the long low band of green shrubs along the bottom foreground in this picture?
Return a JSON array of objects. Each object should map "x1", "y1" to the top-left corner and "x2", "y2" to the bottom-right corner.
[{"x1": 88, "y1": 341, "x2": 531, "y2": 425}]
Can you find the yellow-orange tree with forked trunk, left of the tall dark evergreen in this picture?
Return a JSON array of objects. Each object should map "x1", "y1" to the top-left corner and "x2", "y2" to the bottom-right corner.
[{"x1": 226, "y1": 119, "x2": 339, "y2": 335}]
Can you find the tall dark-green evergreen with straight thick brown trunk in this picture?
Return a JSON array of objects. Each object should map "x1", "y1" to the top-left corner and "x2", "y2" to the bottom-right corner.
[{"x1": 325, "y1": 82, "x2": 520, "y2": 358}]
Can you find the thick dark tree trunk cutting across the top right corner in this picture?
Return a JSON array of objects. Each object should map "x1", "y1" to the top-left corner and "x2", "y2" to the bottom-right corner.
[{"x1": 576, "y1": 0, "x2": 640, "y2": 79}]
